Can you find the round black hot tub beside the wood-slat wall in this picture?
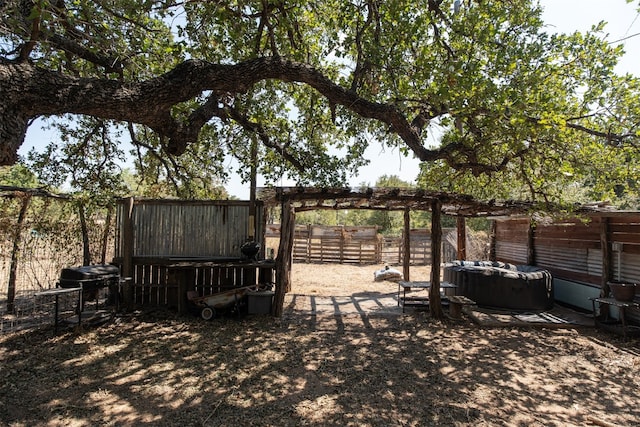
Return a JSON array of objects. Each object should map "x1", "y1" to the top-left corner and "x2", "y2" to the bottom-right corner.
[{"x1": 443, "y1": 261, "x2": 554, "y2": 311}]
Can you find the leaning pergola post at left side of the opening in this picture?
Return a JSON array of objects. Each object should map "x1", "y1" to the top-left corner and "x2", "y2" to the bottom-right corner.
[{"x1": 271, "y1": 200, "x2": 296, "y2": 317}]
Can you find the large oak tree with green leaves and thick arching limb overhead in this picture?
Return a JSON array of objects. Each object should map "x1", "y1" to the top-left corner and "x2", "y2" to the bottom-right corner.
[{"x1": 0, "y1": 0, "x2": 640, "y2": 199}]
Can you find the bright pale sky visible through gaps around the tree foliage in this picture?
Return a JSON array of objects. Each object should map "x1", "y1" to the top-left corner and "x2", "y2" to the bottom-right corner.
[{"x1": 19, "y1": 0, "x2": 640, "y2": 200}]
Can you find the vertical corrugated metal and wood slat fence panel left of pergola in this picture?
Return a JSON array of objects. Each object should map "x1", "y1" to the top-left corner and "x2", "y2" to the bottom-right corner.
[{"x1": 114, "y1": 199, "x2": 270, "y2": 309}]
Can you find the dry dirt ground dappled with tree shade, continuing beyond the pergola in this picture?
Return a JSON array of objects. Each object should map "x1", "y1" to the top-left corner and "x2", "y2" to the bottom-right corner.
[{"x1": 0, "y1": 264, "x2": 640, "y2": 426}]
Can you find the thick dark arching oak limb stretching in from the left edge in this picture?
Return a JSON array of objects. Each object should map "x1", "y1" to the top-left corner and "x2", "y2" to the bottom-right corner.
[{"x1": 0, "y1": 57, "x2": 625, "y2": 171}]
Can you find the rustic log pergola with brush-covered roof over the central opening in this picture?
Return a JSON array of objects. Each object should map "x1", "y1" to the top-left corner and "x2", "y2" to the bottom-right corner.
[{"x1": 259, "y1": 187, "x2": 548, "y2": 318}]
